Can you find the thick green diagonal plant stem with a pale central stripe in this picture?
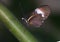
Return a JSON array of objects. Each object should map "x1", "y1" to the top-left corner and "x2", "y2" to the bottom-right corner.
[{"x1": 0, "y1": 4, "x2": 38, "y2": 42}]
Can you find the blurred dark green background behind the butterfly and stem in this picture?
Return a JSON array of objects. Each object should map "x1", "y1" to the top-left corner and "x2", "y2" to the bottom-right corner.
[{"x1": 0, "y1": 0, "x2": 60, "y2": 42}]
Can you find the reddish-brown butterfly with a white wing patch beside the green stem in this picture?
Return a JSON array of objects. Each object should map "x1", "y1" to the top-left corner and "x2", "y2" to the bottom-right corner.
[{"x1": 22, "y1": 5, "x2": 51, "y2": 27}]
